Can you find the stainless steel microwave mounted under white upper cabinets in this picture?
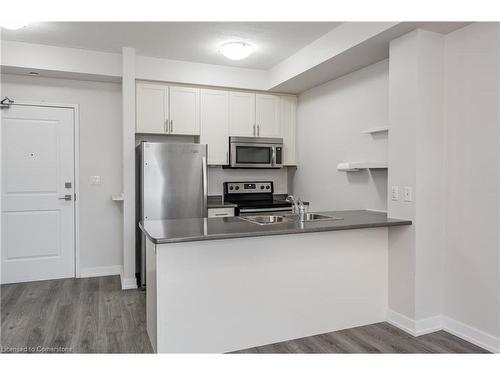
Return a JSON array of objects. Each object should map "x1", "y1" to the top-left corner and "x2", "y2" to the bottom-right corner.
[{"x1": 229, "y1": 137, "x2": 283, "y2": 168}]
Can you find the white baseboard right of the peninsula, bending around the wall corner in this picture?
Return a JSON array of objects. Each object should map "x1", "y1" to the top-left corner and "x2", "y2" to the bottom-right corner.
[{"x1": 386, "y1": 310, "x2": 500, "y2": 353}]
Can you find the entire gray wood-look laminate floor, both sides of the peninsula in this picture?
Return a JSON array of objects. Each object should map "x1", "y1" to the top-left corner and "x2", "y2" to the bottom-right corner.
[{"x1": 0, "y1": 276, "x2": 486, "y2": 353}]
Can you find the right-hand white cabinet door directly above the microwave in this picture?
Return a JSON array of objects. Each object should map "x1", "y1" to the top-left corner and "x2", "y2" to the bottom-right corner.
[{"x1": 255, "y1": 94, "x2": 281, "y2": 137}]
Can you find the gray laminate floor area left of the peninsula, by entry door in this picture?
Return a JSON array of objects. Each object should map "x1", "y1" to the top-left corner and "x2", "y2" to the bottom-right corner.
[{"x1": 0, "y1": 276, "x2": 152, "y2": 353}]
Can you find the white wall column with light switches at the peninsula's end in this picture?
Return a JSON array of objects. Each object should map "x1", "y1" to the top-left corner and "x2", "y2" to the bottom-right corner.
[{"x1": 388, "y1": 30, "x2": 444, "y2": 321}]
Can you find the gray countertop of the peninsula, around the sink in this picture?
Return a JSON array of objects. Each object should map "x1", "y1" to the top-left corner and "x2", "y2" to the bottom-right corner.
[{"x1": 139, "y1": 210, "x2": 412, "y2": 244}]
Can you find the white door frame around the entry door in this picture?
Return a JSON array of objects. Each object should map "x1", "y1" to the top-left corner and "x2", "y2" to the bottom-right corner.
[{"x1": 0, "y1": 100, "x2": 80, "y2": 278}]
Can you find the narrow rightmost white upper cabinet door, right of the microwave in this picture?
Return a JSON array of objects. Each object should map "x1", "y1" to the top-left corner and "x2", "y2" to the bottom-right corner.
[{"x1": 280, "y1": 96, "x2": 297, "y2": 165}]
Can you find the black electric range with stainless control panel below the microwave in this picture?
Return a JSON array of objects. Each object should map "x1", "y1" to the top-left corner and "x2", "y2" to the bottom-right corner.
[{"x1": 224, "y1": 181, "x2": 292, "y2": 215}]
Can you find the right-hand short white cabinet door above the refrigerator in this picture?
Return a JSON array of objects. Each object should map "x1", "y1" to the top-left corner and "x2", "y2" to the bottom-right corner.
[{"x1": 170, "y1": 86, "x2": 200, "y2": 135}]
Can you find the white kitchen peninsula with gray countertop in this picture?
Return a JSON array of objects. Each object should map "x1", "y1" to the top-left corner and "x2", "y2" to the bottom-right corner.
[{"x1": 141, "y1": 211, "x2": 411, "y2": 353}]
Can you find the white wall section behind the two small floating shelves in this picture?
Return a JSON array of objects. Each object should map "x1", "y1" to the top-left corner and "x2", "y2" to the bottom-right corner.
[{"x1": 293, "y1": 60, "x2": 389, "y2": 210}]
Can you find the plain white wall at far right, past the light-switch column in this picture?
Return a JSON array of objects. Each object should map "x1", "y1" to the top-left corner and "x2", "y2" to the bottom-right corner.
[{"x1": 444, "y1": 23, "x2": 500, "y2": 337}]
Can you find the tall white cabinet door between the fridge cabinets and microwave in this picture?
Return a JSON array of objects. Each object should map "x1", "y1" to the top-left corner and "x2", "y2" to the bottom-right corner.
[{"x1": 200, "y1": 89, "x2": 229, "y2": 165}]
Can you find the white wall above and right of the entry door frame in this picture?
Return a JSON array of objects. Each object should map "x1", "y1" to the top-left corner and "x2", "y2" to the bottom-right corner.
[{"x1": 1, "y1": 74, "x2": 122, "y2": 275}]
